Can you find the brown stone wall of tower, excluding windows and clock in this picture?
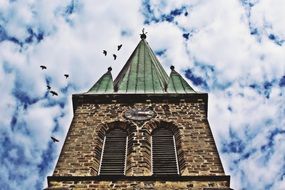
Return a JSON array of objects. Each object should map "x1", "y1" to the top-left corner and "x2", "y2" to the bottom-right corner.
[{"x1": 47, "y1": 95, "x2": 228, "y2": 189}]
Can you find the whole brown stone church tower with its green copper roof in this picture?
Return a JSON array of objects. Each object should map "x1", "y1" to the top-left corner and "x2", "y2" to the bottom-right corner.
[{"x1": 47, "y1": 34, "x2": 230, "y2": 190}]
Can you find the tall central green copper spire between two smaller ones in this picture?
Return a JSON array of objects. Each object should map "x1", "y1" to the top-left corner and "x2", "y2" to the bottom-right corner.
[{"x1": 114, "y1": 36, "x2": 169, "y2": 93}]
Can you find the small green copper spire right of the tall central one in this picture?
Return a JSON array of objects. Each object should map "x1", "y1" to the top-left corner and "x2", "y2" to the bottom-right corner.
[{"x1": 167, "y1": 66, "x2": 195, "y2": 93}]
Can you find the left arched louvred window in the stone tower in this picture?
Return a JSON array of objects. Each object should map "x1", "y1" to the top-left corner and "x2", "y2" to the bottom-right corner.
[{"x1": 99, "y1": 128, "x2": 127, "y2": 175}]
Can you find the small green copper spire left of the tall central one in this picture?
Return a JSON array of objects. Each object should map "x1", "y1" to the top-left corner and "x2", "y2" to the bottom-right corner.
[{"x1": 87, "y1": 67, "x2": 114, "y2": 94}]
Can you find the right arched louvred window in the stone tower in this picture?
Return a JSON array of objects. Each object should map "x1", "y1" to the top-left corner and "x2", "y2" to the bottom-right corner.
[{"x1": 152, "y1": 127, "x2": 179, "y2": 175}]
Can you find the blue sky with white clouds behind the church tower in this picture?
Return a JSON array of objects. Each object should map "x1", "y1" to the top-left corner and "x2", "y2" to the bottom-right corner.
[{"x1": 0, "y1": 0, "x2": 285, "y2": 190}]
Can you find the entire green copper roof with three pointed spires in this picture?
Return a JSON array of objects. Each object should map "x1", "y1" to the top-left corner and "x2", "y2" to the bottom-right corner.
[{"x1": 87, "y1": 33, "x2": 196, "y2": 94}]
